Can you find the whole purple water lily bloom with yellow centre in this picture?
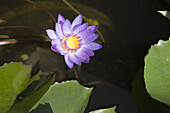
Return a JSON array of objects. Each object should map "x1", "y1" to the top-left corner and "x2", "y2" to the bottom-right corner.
[{"x1": 46, "y1": 14, "x2": 102, "y2": 68}]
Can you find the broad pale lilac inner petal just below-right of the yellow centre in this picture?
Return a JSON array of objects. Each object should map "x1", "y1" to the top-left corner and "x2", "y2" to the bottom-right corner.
[{"x1": 75, "y1": 48, "x2": 90, "y2": 60}]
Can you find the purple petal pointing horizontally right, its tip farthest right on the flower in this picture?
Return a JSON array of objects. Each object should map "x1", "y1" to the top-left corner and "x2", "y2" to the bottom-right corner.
[{"x1": 82, "y1": 42, "x2": 102, "y2": 50}]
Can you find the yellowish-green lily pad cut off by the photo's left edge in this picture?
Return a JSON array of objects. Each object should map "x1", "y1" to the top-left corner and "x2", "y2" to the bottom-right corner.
[{"x1": 0, "y1": 62, "x2": 31, "y2": 113}]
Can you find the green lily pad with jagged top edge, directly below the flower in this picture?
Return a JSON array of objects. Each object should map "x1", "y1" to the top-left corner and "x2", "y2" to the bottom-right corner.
[{"x1": 30, "y1": 81, "x2": 93, "y2": 113}]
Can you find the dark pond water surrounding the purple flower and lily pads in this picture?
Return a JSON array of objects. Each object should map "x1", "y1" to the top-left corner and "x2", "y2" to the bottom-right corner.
[{"x1": 0, "y1": 0, "x2": 170, "y2": 113}]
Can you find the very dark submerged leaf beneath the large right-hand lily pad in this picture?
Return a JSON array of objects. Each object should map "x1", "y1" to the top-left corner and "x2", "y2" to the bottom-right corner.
[{"x1": 132, "y1": 69, "x2": 170, "y2": 113}]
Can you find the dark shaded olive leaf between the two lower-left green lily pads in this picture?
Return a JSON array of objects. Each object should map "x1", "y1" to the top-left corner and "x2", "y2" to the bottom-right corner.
[{"x1": 8, "y1": 75, "x2": 55, "y2": 113}]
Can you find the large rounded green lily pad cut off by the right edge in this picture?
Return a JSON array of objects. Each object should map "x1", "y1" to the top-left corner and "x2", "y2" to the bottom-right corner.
[{"x1": 144, "y1": 40, "x2": 170, "y2": 105}]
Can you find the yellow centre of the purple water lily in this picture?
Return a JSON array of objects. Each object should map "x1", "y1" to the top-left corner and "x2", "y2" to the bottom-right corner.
[{"x1": 61, "y1": 35, "x2": 82, "y2": 52}]
